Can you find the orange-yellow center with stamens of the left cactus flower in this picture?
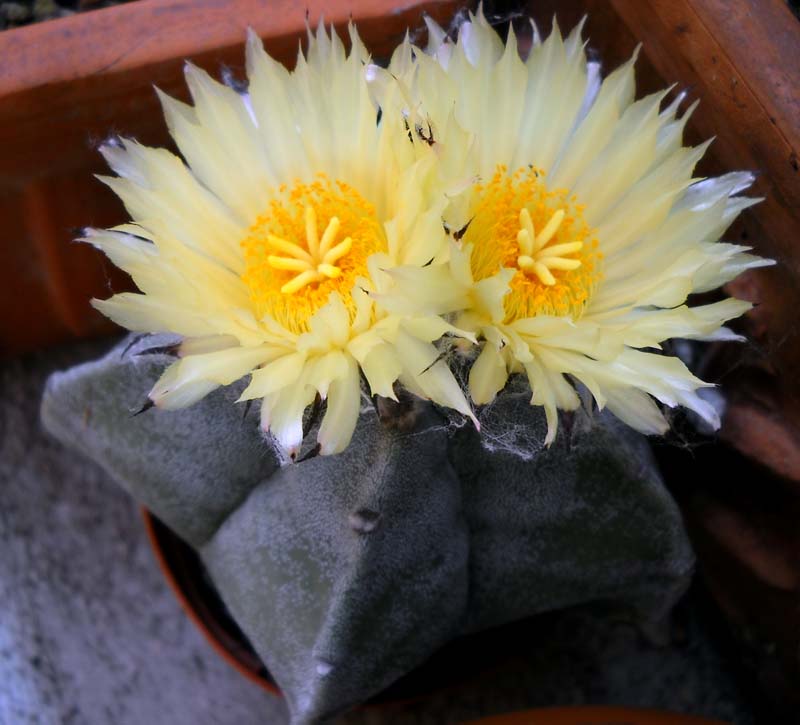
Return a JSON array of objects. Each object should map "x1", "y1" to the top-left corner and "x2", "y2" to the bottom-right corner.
[{"x1": 241, "y1": 175, "x2": 386, "y2": 334}]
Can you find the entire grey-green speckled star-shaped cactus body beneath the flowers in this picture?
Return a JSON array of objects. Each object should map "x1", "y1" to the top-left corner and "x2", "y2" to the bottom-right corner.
[{"x1": 42, "y1": 338, "x2": 694, "y2": 725}]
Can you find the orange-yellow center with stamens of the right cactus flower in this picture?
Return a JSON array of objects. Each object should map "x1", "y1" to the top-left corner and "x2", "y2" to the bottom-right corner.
[{"x1": 463, "y1": 167, "x2": 602, "y2": 322}]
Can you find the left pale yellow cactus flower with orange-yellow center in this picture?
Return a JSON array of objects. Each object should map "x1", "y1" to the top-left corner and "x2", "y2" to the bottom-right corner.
[{"x1": 85, "y1": 26, "x2": 471, "y2": 455}]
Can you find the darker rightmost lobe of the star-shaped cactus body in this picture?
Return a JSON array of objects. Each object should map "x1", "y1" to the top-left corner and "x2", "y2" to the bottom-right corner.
[{"x1": 450, "y1": 390, "x2": 694, "y2": 631}]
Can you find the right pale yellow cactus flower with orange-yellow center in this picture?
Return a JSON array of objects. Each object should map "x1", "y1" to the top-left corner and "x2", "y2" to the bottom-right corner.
[{"x1": 370, "y1": 11, "x2": 772, "y2": 443}]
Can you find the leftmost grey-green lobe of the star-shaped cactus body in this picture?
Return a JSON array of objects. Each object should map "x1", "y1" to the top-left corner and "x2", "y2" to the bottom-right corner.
[{"x1": 41, "y1": 335, "x2": 279, "y2": 546}]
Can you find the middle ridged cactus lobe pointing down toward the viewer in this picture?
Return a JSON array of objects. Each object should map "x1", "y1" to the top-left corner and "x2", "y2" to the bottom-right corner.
[{"x1": 202, "y1": 409, "x2": 468, "y2": 722}]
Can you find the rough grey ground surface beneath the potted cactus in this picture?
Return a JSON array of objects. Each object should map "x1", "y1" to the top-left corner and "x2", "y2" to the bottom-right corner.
[{"x1": 0, "y1": 342, "x2": 755, "y2": 725}]
